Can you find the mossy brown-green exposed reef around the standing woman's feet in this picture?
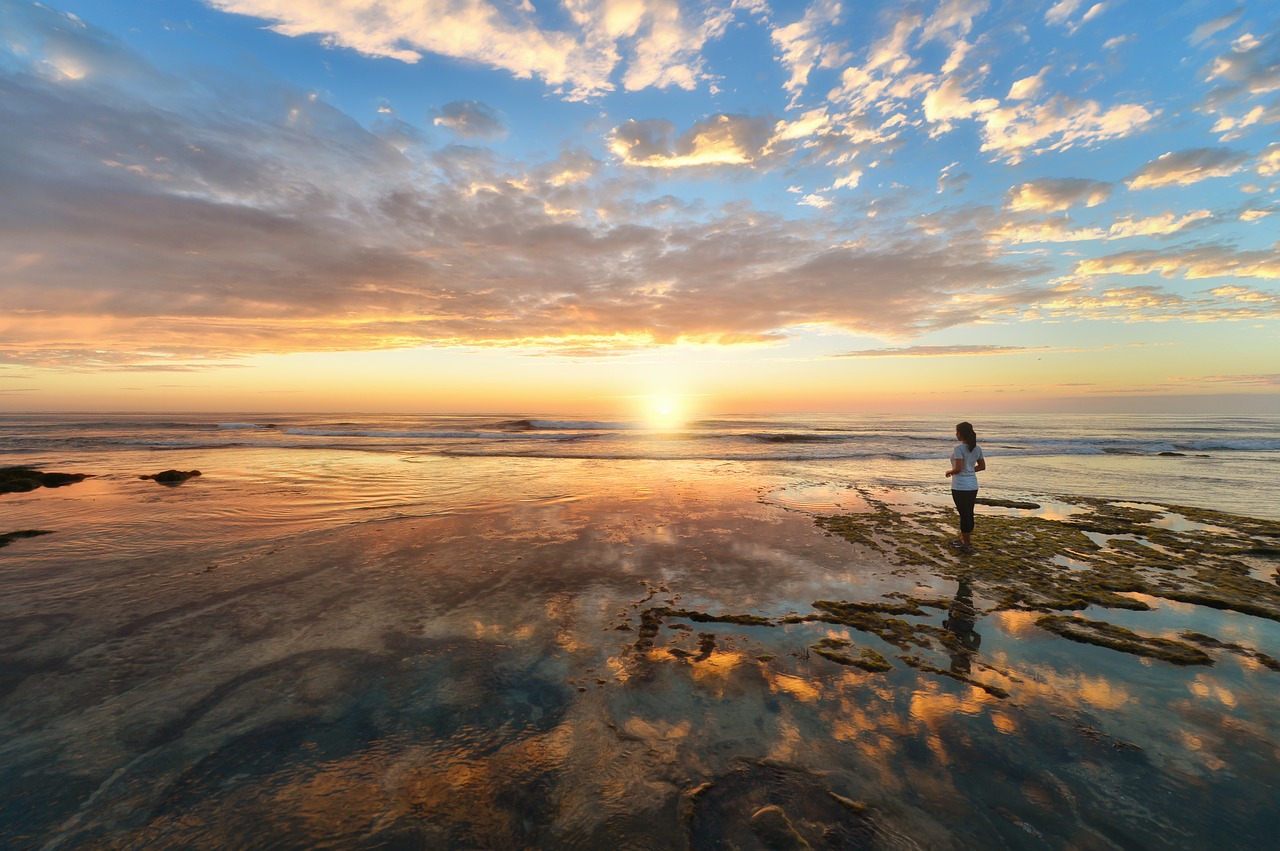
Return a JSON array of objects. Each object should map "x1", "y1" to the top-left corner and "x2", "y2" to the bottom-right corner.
[{"x1": 796, "y1": 493, "x2": 1280, "y2": 669}]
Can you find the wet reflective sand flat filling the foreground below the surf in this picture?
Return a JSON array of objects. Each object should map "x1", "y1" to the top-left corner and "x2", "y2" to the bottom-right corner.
[{"x1": 0, "y1": 466, "x2": 1280, "y2": 848}]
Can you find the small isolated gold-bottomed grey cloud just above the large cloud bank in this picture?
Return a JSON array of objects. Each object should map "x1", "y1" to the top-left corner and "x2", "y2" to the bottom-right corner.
[{"x1": 609, "y1": 115, "x2": 774, "y2": 169}]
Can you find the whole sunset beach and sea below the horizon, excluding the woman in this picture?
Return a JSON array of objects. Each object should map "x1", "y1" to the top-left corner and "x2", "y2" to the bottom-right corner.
[{"x1": 0, "y1": 415, "x2": 1280, "y2": 848}]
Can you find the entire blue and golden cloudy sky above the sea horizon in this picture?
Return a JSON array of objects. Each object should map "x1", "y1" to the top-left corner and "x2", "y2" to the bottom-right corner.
[{"x1": 0, "y1": 0, "x2": 1280, "y2": 415}]
